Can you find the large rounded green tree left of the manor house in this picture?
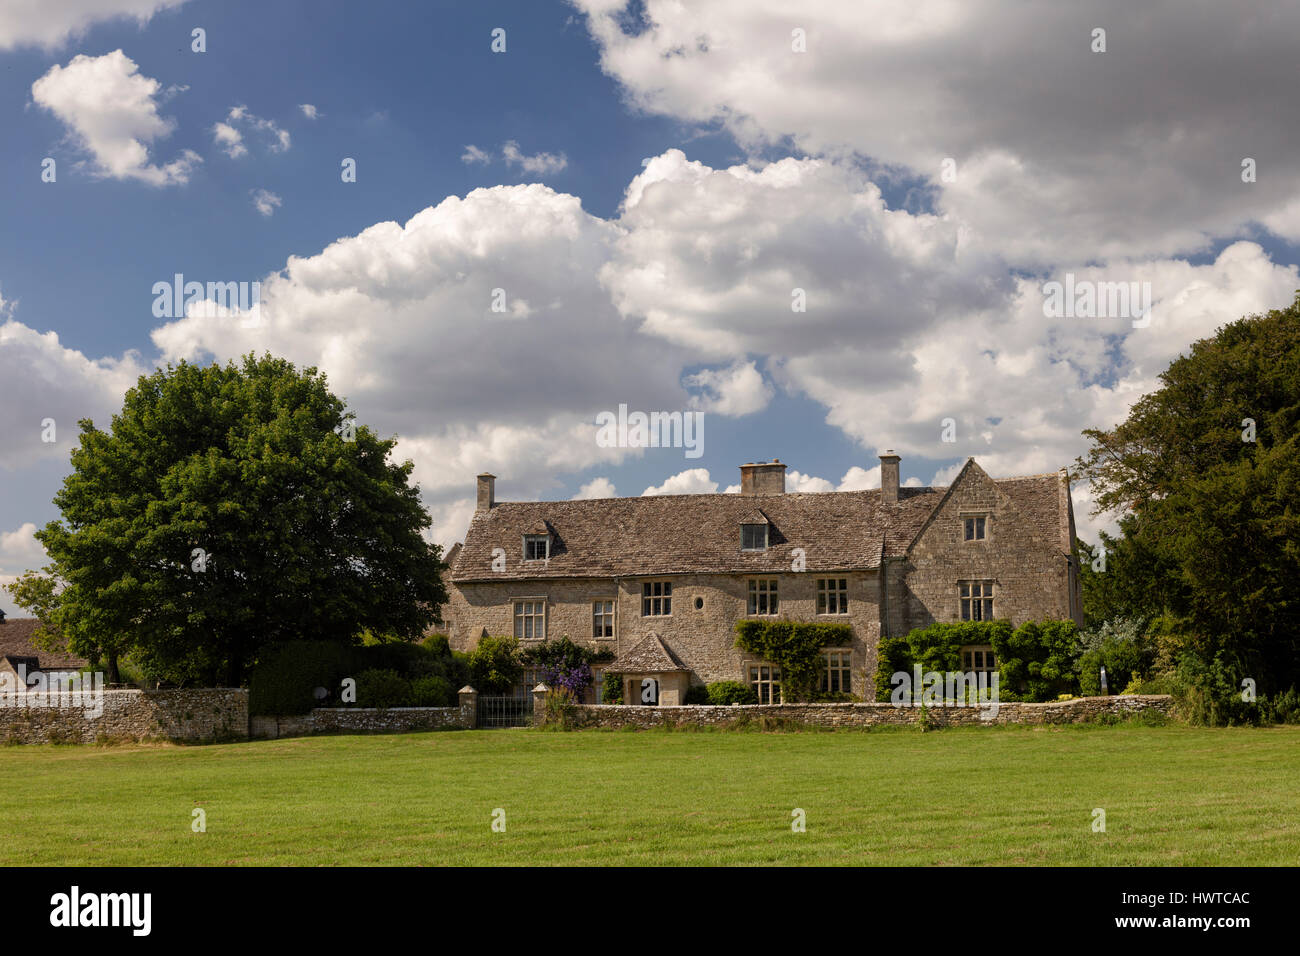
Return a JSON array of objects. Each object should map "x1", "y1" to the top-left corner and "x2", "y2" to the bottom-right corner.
[{"x1": 29, "y1": 355, "x2": 446, "y2": 684}]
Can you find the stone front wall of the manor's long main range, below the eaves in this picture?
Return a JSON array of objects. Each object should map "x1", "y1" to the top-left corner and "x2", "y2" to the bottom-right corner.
[{"x1": 449, "y1": 567, "x2": 880, "y2": 695}]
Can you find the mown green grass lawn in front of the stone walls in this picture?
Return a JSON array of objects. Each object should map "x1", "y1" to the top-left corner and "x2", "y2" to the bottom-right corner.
[{"x1": 0, "y1": 726, "x2": 1300, "y2": 866}]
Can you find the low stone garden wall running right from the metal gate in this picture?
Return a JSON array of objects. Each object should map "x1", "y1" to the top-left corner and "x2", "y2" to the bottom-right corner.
[{"x1": 564, "y1": 695, "x2": 1173, "y2": 730}]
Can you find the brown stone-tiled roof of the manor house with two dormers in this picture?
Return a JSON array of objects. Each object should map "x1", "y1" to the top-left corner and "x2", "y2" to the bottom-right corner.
[{"x1": 451, "y1": 465, "x2": 1062, "y2": 583}]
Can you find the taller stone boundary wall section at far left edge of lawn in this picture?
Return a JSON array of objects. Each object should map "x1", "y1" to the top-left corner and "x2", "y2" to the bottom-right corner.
[{"x1": 0, "y1": 688, "x2": 248, "y2": 744}]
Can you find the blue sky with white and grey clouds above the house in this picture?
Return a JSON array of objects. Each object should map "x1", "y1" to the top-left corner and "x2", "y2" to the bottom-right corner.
[{"x1": 0, "y1": 0, "x2": 1300, "y2": 613}]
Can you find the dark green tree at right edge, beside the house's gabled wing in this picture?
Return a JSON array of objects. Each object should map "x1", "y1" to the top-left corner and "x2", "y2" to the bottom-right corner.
[{"x1": 1076, "y1": 295, "x2": 1300, "y2": 689}]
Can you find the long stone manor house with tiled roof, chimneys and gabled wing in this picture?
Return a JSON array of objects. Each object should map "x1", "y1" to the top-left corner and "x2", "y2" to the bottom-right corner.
[{"x1": 442, "y1": 453, "x2": 1082, "y2": 705}]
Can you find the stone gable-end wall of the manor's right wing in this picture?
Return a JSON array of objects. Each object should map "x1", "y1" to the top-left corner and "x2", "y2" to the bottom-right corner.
[{"x1": 889, "y1": 466, "x2": 1079, "y2": 633}]
